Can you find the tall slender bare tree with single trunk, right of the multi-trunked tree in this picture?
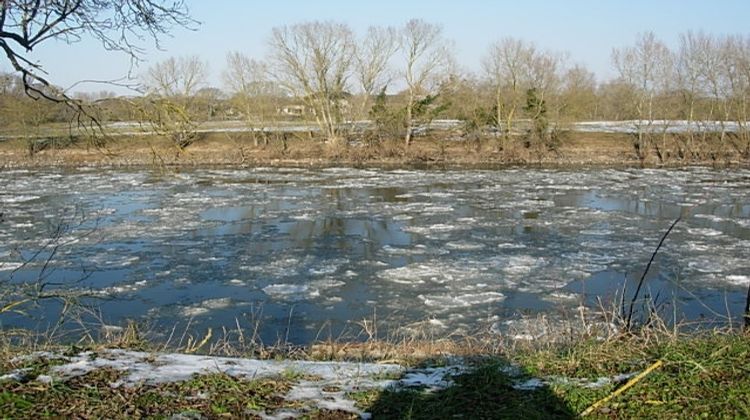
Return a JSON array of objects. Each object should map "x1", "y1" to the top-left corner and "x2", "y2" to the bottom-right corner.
[{"x1": 400, "y1": 19, "x2": 451, "y2": 147}]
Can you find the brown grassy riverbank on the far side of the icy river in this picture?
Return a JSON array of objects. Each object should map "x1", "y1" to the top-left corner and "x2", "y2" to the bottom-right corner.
[{"x1": 0, "y1": 132, "x2": 748, "y2": 168}]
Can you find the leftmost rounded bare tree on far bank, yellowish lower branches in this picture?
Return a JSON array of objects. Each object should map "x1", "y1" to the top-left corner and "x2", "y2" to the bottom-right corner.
[{"x1": 144, "y1": 56, "x2": 208, "y2": 150}]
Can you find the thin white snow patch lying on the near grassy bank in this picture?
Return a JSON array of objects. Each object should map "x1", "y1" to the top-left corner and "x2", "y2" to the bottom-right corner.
[{"x1": 13, "y1": 349, "x2": 467, "y2": 418}]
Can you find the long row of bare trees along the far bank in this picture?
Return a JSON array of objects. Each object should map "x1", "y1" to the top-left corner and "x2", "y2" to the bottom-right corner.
[{"x1": 0, "y1": 20, "x2": 750, "y2": 160}]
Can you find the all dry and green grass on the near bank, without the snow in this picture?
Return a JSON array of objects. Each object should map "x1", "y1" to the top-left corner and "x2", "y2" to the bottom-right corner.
[{"x1": 0, "y1": 296, "x2": 750, "y2": 418}]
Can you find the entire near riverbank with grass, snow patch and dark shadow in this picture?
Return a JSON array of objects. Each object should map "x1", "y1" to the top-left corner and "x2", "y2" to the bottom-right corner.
[{"x1": 0, "y1": 331, "x2": 750, "y2": 419}]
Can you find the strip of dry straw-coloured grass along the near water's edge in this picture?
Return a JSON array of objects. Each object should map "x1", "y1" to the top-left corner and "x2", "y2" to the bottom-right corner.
[{"x1": 0, "y1": 294, "x2": 694, "y2": 365}]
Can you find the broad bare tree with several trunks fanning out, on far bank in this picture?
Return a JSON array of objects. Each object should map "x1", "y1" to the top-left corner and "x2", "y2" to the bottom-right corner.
[{"x1": 270, "y1": 22, "x2": 354, "y2": 143}]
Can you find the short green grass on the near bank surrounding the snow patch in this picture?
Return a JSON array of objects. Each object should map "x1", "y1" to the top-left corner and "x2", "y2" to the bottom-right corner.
[{"x1": 0, "y1": 331, "x2": 750, "y2": 419}]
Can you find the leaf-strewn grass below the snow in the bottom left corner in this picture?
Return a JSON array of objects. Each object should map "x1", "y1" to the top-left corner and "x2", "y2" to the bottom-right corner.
[{"x1": 0, "y1": 369, "x2": 297, "y2": 418}]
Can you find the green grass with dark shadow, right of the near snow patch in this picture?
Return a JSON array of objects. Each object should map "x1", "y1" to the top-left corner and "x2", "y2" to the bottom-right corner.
[{"x1": 355, "y1": 333, "x2": 750, "y2": 419}]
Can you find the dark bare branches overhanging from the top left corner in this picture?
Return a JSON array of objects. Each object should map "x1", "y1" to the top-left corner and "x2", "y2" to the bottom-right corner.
[{"x1": 0, "y1": 0, "x2": 195, "y2": 111}]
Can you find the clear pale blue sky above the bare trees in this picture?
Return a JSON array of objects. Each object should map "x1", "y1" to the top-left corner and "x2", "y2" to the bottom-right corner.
[{"x1": 10, "y1": 0, "x2": 750, "y2": 94}]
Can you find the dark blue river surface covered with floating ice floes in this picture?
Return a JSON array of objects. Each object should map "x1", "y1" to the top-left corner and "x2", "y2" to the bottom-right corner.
[{"x1": 0, "y1": 168, "x2": 750, "y2": 342}]
